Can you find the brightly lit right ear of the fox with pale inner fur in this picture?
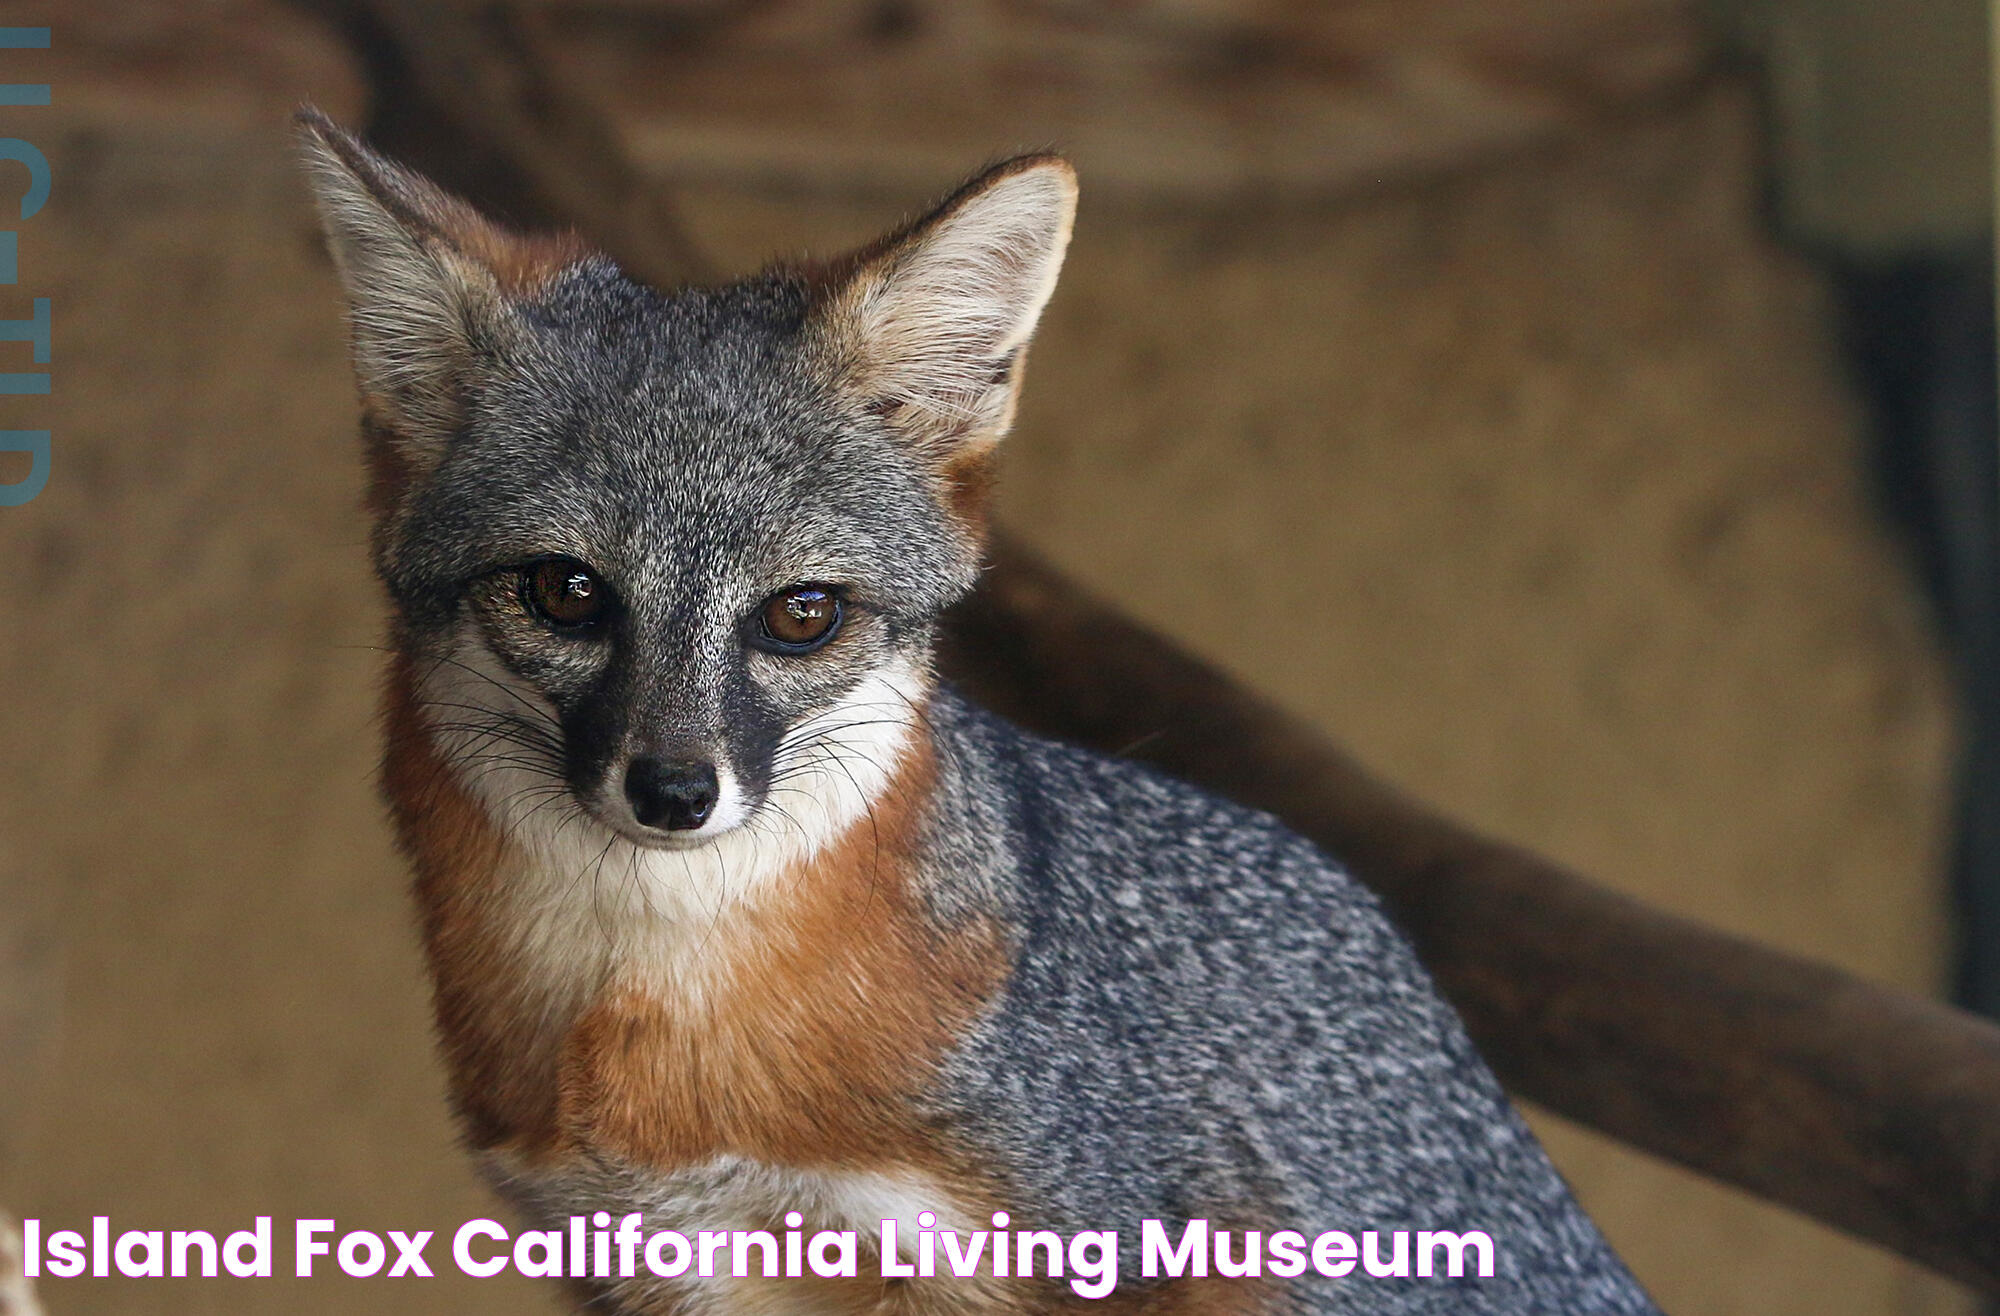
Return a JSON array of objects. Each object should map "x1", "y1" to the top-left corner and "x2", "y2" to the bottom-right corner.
[{"x1": 826, "y1": 156, "x2": 1076, "y2": 462}]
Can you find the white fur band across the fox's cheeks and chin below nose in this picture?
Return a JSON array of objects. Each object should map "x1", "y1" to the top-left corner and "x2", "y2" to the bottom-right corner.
[{"x1": 418, "y1": 640, "x2": 924, "y2": 934}]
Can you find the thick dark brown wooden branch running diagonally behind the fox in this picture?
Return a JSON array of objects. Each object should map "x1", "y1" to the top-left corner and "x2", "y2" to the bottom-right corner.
[{"x1": 300, "y1": 0, "x2": 2000, "y2": 1294}]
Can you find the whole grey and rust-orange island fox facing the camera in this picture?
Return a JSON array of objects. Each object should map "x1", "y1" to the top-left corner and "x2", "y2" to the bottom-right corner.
[{"x1": 300, "y1": 110, "x2": 1654, "y2": 1316}]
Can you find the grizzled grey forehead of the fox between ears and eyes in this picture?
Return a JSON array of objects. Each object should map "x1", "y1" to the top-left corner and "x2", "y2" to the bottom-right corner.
[{"x1": 390, "y1": 264, "x2": 964, "y2": 608}]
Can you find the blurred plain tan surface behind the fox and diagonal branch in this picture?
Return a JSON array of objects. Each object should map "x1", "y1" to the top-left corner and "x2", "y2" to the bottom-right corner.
[{"x1": 0, "y1": 25, "x2": 1964, "y2": 1316}]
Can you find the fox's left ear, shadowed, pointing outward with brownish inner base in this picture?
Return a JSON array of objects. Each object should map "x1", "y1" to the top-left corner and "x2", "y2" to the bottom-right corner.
[{"x1": 298, "y1": 108, "x2": 584, "y2": 474}]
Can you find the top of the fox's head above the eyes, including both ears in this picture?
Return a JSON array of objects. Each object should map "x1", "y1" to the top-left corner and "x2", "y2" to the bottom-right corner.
[{"x1": 300, "y1": 112, "x2": 1076, "y2": 622}]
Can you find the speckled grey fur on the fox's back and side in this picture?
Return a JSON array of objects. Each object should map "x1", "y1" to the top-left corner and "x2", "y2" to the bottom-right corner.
[{"x1": 908, "y1": 692, "x2": 1654, "y2": 1314}]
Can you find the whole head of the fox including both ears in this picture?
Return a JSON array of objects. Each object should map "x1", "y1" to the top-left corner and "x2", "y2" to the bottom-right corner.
[{"x1": 302, "y1": 112, "x2": 1076, "y2": 892}]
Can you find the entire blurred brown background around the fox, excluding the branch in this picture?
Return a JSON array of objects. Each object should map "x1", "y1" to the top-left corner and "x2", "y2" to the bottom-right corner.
[{"x1": 0, "y1": 0, "x2": 2000, "y2": 1316}]
